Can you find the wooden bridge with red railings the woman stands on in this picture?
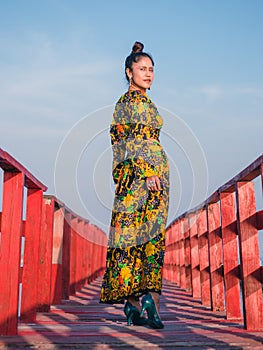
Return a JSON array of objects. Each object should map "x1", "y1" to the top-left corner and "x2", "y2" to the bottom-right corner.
[{"x1": 0, "y1": 149, "x2": 263, "y2": 349}]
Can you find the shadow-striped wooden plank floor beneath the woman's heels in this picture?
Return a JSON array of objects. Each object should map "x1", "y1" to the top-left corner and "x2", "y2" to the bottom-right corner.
[{"x1": 0, "y1": 279, "x2": 263, "y2": 350}]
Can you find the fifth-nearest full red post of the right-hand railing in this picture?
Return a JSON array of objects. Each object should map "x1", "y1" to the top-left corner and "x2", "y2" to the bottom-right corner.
[{"x1": 189, "y1": 213, "x2": 201, "y2": 299}]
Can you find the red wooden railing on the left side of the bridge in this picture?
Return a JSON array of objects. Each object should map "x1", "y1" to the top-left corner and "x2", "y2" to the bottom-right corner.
[{"x1": 0, "y1": 149, "x2": 107, "y2": 335}]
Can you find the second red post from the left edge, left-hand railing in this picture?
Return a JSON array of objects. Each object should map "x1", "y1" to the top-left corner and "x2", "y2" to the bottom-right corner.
[{"x1": 20, "y1": 188, "x2": 43, "y2": 322}]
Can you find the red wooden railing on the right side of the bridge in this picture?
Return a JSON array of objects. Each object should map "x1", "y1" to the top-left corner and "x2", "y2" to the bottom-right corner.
[{"x1": 164, "y1": 156, "x2": 263, "y2": 330}]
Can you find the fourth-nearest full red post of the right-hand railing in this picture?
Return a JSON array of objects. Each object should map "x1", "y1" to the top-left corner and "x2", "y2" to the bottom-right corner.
[{"x1": 197, "y1": 209, "x2": 211, "y2": 306}]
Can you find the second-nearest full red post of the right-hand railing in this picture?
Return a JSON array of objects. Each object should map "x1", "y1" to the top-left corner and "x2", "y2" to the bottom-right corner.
[{"x1": 220, "y1": 192, "x2": 242, "y2": 320}]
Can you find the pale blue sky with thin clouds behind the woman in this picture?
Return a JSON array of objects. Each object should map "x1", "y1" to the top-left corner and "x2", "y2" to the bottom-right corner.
[{"x1": 0, "y1": 0, "x2": 263, "y2": 231}]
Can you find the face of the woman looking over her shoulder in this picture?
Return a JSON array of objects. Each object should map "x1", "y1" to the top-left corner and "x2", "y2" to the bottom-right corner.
[{"x1": 127, "y1": 57, "x2": 154, "y2": 92}]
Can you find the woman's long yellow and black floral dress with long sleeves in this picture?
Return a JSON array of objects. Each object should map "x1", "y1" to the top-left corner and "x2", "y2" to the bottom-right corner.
[{"x1": 100, "y1": 90, "x2": 169, "y2": 304}]
